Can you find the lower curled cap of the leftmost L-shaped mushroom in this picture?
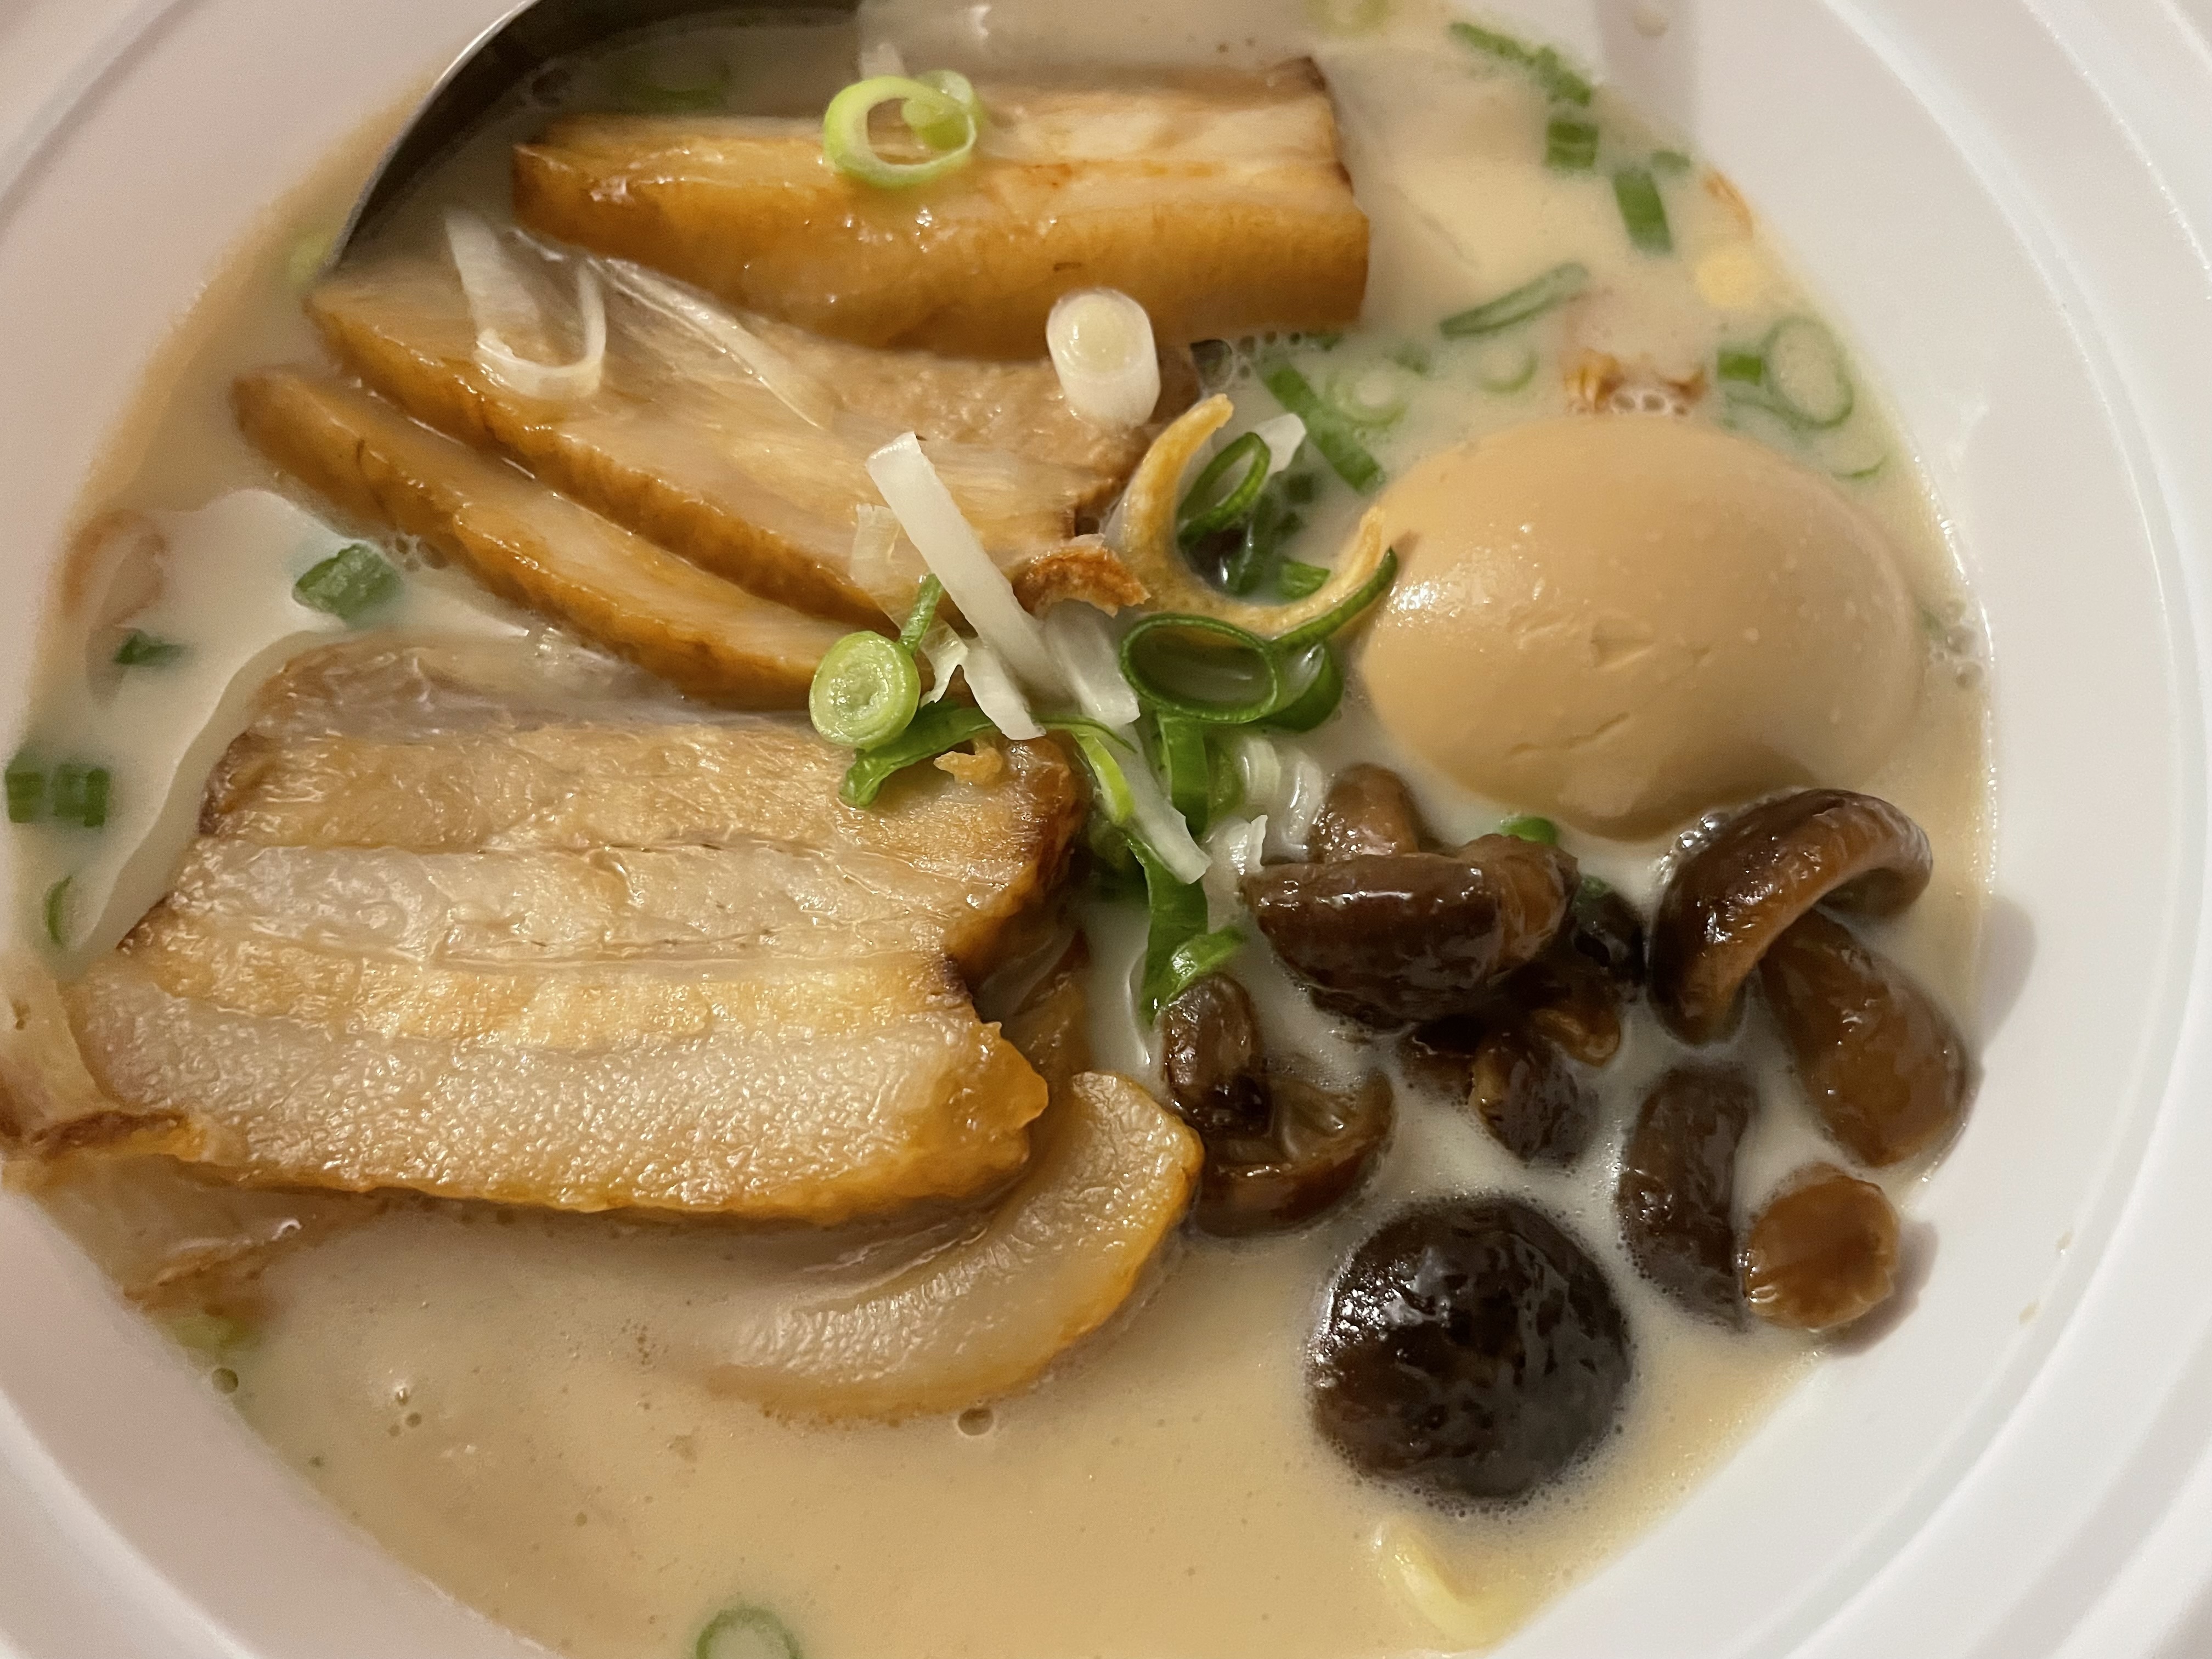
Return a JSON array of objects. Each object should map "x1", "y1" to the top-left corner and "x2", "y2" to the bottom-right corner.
[{"x1": 1194, "y1": 1070, "x2": 1391, "y2": 1239}]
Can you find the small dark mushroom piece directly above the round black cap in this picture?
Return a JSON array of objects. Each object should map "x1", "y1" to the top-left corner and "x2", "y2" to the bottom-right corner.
[{"x1": 1398, "y1": 1013, "x2": 1597, "y2": 1166}]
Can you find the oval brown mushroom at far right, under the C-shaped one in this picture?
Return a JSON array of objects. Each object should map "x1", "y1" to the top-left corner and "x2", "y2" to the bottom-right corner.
[{"x1": 1758, "y1": 911, "x2": 1968, "y2": 1168}]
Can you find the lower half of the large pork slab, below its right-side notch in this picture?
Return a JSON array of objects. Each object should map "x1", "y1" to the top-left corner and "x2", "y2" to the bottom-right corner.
[{"x1": 64, "y1": 934, "x2": 1044, "y2": 1223}]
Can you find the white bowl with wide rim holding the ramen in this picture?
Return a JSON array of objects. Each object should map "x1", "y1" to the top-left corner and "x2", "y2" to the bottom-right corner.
[{"x1": 0, "y1": 0, "x2": 2212, "y2": 1659}]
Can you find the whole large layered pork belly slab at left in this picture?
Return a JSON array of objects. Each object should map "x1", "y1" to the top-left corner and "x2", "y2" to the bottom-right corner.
[{"x1": 0, "y1": 644, "x2": 1082, "y2": 1223}]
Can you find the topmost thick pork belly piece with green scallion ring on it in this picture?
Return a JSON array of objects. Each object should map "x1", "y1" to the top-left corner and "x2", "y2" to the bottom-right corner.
[{"x1": 515, "y1": 62, "x2": 1367, "y2": 358}]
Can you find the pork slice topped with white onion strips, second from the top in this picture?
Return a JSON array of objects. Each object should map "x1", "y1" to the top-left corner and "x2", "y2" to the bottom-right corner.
[{"x1": 309, "y1": 250, "x2": 1172, "y2": 622}]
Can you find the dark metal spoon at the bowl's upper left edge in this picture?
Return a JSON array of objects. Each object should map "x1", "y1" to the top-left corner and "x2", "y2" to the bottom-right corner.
[{"x1": 328, "y1": 0, "x2": 858, "y2": 266}]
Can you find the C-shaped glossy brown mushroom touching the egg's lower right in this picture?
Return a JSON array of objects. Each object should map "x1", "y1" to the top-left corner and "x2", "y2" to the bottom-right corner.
[{"x1": 1650, "y1": 789, "x2": 1933, "y2": 1042}]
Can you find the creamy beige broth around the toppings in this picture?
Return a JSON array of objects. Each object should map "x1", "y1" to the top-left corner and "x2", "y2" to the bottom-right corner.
[{"x1": 18, "y1": 0, "x2": 1989, "y2": 1659}]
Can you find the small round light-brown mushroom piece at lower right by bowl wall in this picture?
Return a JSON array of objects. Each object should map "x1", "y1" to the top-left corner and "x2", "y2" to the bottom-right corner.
[{"x1": 1743, "y1": 1164, "x2": 1898, "y2": 1331}]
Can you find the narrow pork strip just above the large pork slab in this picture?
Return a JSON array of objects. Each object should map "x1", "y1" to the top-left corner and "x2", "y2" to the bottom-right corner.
[{"x1": 236, "y1": 369, "x2": 840, "y2": 708}]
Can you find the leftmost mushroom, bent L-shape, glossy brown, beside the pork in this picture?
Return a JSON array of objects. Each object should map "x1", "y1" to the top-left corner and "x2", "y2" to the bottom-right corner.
[{"x1": 1161, "y1": 973, "x2": 1391, "y2": 1237}]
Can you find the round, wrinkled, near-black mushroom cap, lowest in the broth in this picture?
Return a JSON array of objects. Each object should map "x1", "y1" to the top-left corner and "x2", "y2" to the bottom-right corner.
[{"x1": 1307, "y1": 1197, "x2": 1630, "y2": 1500}]
